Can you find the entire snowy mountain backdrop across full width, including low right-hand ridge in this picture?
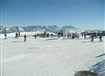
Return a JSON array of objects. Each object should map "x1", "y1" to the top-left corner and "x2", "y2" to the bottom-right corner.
[{"x1": 0, "y1": 25, "x2": 105, "y2": 36}]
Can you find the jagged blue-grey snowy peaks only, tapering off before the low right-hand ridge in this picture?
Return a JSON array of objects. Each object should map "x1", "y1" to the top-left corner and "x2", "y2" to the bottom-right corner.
[{"x1": 0, "y1": 25, "x2": 78, "y2": 33}]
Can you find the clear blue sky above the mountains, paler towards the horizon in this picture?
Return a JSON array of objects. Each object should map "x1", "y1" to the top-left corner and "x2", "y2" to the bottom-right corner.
[{"x1": 0, "y1": 0, "x2": 105, "y2": 29}]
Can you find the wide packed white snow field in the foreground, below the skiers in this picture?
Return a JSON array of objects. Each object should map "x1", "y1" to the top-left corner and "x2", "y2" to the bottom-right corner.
[{"x1": 0, "y1": 32, "x2": 105, "y2": 76}]
